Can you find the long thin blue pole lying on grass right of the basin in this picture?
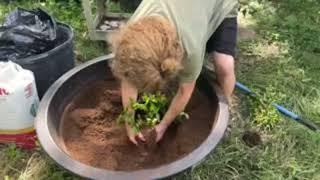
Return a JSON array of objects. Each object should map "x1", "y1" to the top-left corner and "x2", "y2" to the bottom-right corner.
[{"x1": 236, "y1": 82, "x2": 320, "y2": 131}]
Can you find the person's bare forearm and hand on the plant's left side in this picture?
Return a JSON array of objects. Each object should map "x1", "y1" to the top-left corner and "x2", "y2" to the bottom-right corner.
[{"x1": 121, "y1": 80, "x2": 144, "y2": 145}]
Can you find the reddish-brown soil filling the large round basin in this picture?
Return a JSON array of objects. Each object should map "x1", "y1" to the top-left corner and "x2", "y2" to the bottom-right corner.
[{"x1": 61, "y1": 81, "x2": 216, "y2": 171}]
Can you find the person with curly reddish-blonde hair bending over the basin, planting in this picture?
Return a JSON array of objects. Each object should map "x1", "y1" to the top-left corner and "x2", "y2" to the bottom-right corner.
[{"x1": 111, "y1": 0, "x2": 238, "y2": 144}]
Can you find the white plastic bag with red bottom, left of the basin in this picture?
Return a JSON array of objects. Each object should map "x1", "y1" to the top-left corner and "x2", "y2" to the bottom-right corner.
[{"x1": 0, "y1": 61, "x2": 39, "y2": 148}]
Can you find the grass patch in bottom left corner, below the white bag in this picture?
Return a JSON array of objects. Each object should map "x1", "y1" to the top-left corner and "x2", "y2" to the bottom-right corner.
[{"x1": 0, "y1": 145, "x2": 80, "y2": 180}]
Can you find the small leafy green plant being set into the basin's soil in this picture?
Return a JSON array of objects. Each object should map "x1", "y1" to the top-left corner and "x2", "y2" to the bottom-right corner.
[{"x1": 117, "y1": 92, "x2": 189, "y2": 132}]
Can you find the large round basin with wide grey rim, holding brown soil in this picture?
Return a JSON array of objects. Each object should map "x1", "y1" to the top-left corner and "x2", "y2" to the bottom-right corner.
[{"x1": 35, "y1": 55, "x2": 229, "y2": 180}]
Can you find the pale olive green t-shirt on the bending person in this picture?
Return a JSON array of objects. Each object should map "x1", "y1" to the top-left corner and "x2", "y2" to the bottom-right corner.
[{"x1": 130, "y1": 0, "x2": 238, "y2": 82}]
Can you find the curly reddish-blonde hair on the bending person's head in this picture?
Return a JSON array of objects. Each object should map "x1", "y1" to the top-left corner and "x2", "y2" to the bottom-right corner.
[{"x1": 111, "y1": 16, "x2": 184, "y2": 91}]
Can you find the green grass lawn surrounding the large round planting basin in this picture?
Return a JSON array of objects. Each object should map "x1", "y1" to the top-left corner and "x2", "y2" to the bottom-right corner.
[{"x1": 0, "y1": 0, "x2": 320, "y2": 180}]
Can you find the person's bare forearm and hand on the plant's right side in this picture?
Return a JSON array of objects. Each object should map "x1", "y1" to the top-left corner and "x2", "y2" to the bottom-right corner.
[{"x1": 156, "y1": 81, "x2": 196, "y2": 142}]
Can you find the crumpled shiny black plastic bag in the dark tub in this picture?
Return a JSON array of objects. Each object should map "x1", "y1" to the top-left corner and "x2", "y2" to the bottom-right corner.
[{"x1": 0, "y1": 8, "x2": 56, "y2": 61}]
